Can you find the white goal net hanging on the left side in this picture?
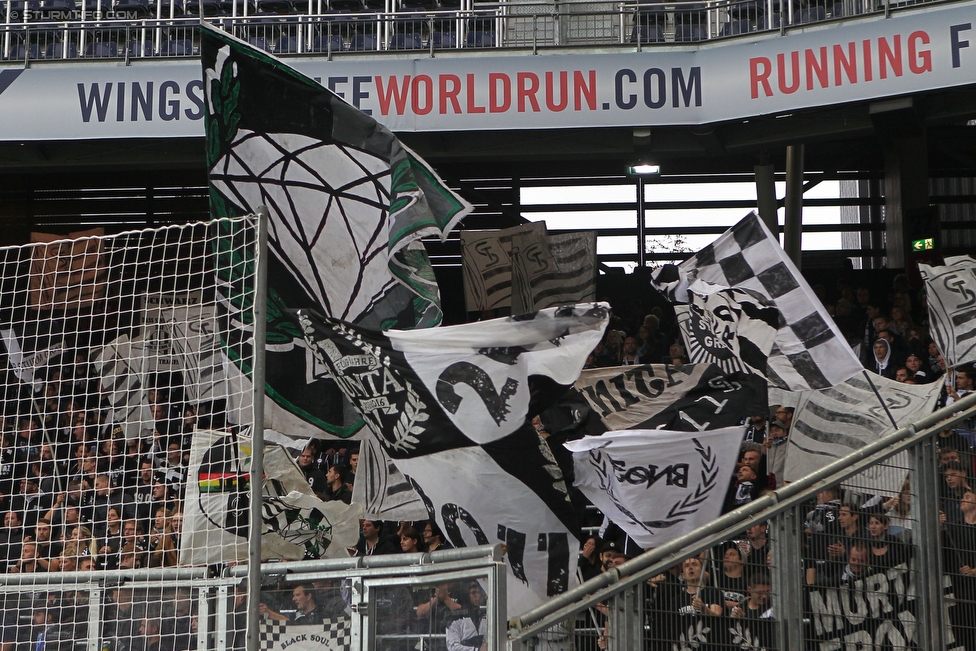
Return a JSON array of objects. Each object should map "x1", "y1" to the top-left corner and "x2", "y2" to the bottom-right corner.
[{"x1": 0, "y1": 218, "x2": 256, "y2": 651}]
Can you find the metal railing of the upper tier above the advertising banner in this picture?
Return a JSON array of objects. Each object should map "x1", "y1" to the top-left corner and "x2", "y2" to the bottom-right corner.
[{"x1": 0, "y1": 0, "x2": 945, "y2": 62}]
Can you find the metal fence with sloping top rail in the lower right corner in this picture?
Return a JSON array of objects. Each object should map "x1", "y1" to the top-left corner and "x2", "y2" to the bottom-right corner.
[{"x1": 509, "y1": 395, "x2": 976, "y2": 651}]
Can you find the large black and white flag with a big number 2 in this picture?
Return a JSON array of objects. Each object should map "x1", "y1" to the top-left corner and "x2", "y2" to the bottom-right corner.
[{"x1": 296, "y1": 304, "x2": 609, "y2": 616}]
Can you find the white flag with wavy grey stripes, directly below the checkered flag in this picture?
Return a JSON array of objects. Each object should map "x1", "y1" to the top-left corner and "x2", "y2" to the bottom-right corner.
[{"x1": 784, "y1": 371, "x2": 942, "y2": 494}]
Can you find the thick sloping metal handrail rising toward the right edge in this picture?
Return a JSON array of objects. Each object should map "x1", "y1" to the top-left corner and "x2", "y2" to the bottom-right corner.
[{"x1": 509, "y1": 393, "x2": 976, "y2": 641}]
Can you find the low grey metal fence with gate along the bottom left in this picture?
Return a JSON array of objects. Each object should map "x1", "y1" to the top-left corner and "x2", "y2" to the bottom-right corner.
[{"x1": 0, "y1": 545, "x2": 505, "y2": 651}]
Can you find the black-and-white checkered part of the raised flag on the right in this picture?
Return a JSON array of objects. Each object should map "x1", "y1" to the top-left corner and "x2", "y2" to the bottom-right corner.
[{"x1": 652, "y1": 213, "x2": 863, "y2": 391}]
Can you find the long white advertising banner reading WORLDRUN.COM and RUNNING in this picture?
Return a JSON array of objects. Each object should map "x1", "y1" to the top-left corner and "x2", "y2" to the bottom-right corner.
[{"x1": 0, "y1": 3, "x2": 976, "y2": 141}]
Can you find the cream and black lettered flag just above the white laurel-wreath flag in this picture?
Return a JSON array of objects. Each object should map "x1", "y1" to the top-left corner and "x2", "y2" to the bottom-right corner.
[{"x1": 574, "y1": 364, "x2": 768, "y2": 432}]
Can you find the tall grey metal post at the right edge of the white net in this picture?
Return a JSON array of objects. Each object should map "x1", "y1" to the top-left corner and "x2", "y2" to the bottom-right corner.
[{"x1": 245, "y1": 206, "x2": 268, "y2": 651}]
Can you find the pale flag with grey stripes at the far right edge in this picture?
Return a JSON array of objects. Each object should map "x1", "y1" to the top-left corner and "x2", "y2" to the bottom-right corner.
[{"x1": 918, "y1": 255, "x2": 976, "y2": 366}]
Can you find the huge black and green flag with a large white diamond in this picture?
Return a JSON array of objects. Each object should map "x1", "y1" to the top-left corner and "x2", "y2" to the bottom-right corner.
[{"x1": 201, "y1": 23, "x2": 471, "y2": 438}]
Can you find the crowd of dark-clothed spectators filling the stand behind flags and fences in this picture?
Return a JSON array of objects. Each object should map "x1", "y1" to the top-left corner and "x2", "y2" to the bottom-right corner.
[{"x1": 0, "y1": 277, "x2": 976, "y2": 651}]
